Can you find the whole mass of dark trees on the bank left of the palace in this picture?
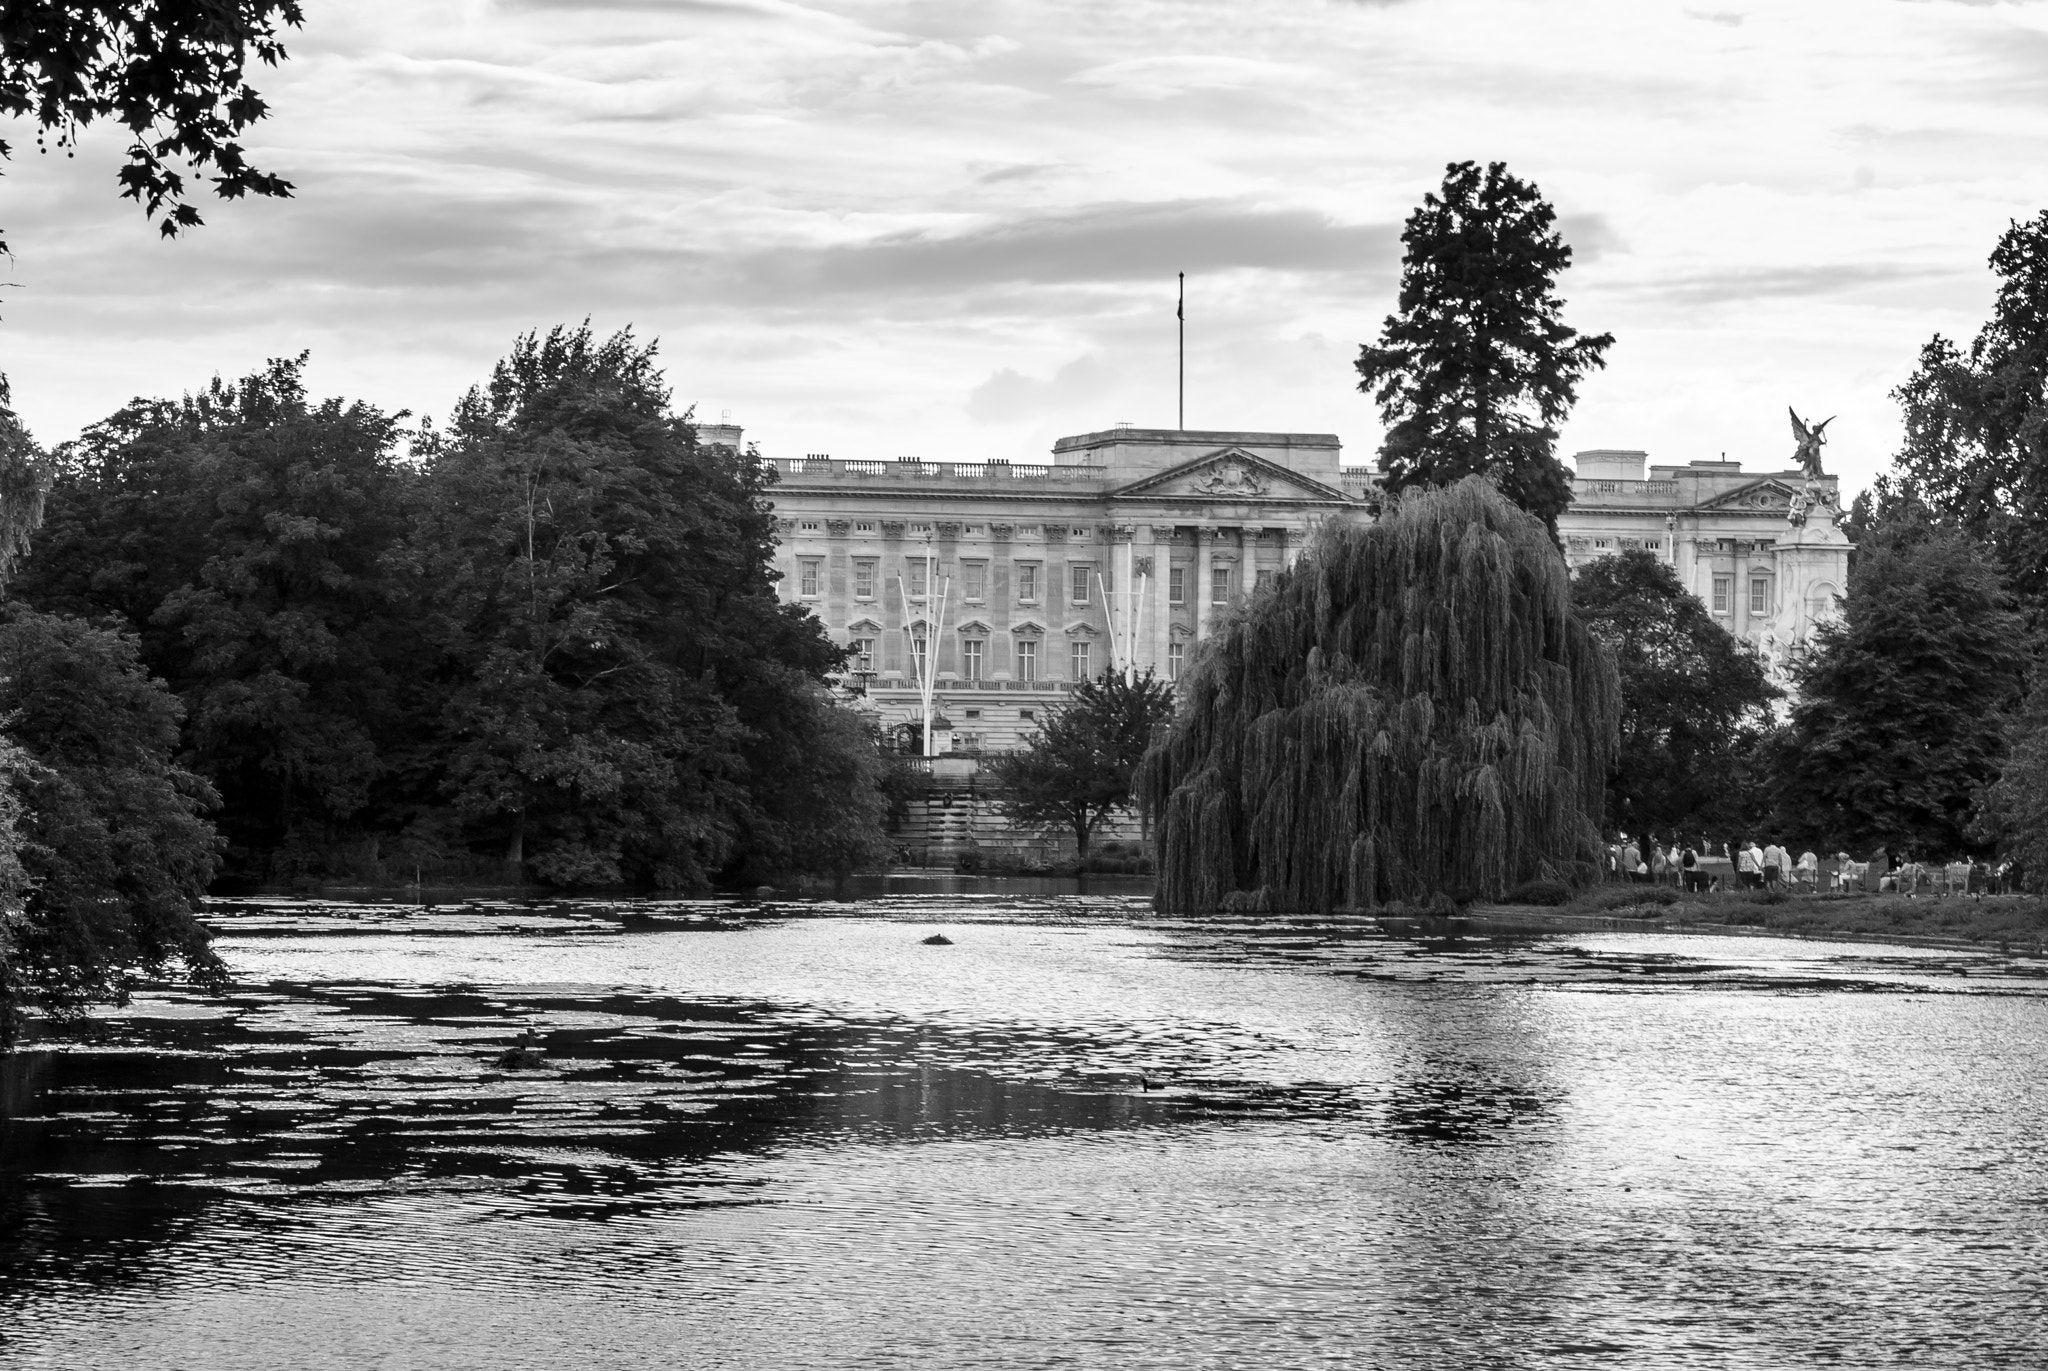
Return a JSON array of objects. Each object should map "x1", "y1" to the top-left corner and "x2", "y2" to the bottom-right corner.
[{"x1": 16, "y1": 328, "x2": 883, "y2": 887}]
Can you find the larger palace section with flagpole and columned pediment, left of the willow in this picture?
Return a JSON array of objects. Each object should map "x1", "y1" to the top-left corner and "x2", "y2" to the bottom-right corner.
[{"x1": 757, "y1": 426, "x2": 1368, "y2": 752}]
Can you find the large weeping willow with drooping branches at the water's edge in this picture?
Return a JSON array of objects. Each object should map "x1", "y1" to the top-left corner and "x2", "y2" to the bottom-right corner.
[{"x1": 1141, "y1": 477, "x2": 1622, "y2": 912}]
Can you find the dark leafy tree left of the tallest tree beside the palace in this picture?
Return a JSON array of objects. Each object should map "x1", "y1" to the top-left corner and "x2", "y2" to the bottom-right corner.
[{"x1": 18, "y1": 355, "x2": 422, "y2": 875}]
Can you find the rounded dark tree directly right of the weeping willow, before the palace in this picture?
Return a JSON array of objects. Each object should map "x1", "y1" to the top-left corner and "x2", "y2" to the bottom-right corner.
[{"x1": 1571, "y1": 549, "x2": 1780, "y2": 836}]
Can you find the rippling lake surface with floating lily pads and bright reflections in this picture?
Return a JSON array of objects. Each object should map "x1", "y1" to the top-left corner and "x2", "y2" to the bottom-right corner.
[{"x1": 0, "y1": 887, "x2": 2048, "y2": 1367}]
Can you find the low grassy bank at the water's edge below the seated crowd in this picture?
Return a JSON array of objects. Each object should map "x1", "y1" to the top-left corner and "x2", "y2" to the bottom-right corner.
[{"x1": 1530, "y1": 885, "x2": 2048, "y2": 951}]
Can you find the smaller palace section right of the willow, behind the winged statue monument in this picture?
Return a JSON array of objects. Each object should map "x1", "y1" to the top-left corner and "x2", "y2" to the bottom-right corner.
[{"x1": 1559, "y1": 451, "x2": 1849, "y2": 684}]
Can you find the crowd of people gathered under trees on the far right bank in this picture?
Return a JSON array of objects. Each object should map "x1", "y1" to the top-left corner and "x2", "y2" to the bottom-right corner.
[{"x1": 1608, "y1": 834, "x2": 2013, "y2": 896}]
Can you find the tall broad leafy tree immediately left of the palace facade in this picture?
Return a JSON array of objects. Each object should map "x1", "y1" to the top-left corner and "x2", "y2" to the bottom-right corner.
[{"x1": 416, "y1": 324, "x2": 864, "y2": 887}]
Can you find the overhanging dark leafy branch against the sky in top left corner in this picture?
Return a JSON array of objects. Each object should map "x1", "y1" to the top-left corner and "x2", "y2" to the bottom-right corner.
[{"x1": 0, "y1": 0, "x2": 305, "y2": 252}]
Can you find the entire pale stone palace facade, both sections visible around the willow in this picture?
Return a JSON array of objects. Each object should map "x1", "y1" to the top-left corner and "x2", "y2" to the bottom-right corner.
[{"x1": 741, "y1": 424, "x2": 1849, "y2": 754}]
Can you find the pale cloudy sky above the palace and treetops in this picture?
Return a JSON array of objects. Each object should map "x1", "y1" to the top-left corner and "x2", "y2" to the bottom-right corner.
[{"x1": 0, "y1": 0, "x2": 2048, "y2": 490}]
